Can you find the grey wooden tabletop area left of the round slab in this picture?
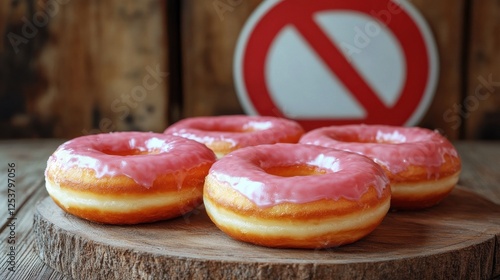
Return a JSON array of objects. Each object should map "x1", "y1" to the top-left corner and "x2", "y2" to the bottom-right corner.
[{"x1": 0, "y1": 140, "x2": 69, "y2": 280}]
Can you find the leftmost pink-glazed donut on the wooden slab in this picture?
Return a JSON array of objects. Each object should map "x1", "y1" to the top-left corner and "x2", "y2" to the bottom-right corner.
[{"x1": 45, "y1": 132, "x2": 216, "y2": 224}]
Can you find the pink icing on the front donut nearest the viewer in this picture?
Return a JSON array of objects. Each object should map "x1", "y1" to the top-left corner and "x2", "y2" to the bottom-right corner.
[{"x1": 209, "y1": 144, "x2": 389, "y2": 207}]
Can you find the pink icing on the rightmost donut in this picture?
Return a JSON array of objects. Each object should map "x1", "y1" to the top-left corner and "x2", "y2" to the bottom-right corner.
[{"x1": 299, "y1": 125, "x2": 459, "y2": 178}]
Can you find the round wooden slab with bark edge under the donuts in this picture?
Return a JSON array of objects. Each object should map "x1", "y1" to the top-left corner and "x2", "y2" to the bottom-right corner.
[{"x1": 34, "y1": 187, "x2": 500, "y2": 279}]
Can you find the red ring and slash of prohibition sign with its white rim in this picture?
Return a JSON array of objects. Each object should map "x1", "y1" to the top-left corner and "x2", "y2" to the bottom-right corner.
[{"x1": 234, "y1": 0, "x2": 438, "y2": 130}]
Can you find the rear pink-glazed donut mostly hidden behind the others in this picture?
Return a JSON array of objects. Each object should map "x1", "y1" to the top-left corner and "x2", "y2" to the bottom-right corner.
[{"x1": 164, "y1": 115, "x2": 304, "y2": 158}]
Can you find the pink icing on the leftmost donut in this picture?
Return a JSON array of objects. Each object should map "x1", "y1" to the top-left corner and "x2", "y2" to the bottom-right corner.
[{"x1": 45, "y1": 132, "x2": 215, "y2": 188}]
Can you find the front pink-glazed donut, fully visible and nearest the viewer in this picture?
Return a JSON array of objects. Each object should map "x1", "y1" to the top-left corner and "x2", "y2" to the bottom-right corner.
[{"x1": 203, "y1": 143, "x2": 390, "y2": 248}]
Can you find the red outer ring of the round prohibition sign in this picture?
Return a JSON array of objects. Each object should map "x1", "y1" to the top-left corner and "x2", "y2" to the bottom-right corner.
[{"x1": 242, "y1": 0, "x2": 430, "y2": 130}]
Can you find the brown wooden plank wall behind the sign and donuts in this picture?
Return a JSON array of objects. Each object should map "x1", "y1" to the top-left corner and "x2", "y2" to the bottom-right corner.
[{"x1": 0, "y1": 0, "x2": 500, "y2": 139}]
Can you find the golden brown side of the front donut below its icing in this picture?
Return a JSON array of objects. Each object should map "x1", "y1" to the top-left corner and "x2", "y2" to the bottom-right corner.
[{"x1": 204, "y1": 175, "x2": 391, "y2": 248}]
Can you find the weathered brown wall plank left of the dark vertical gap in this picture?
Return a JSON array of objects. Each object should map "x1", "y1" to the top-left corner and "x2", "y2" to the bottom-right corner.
[{"x1": 0, "y1": 0, "x2": 168, "y2": 138}]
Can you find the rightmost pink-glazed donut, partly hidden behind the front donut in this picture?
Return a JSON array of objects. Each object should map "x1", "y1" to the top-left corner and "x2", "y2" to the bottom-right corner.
[{"x1": 300, "y1": 125, "x2": 461, "y2": 209}]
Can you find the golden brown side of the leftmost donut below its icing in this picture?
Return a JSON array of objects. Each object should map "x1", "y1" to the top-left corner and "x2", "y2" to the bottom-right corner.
[{"x1": 46, "y1": 163, "x2": 211, "y2": 224}]
